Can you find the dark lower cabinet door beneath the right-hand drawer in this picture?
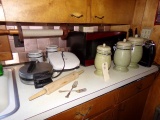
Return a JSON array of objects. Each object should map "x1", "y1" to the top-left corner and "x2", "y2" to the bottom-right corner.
[{"x1": 116, "y1": 88, "x2": 149, "y2": 120}]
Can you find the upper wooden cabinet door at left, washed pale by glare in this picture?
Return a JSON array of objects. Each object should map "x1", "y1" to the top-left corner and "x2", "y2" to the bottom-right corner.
[{"x1": 1, "y1": 0, "x2": 88, "y2": 23}]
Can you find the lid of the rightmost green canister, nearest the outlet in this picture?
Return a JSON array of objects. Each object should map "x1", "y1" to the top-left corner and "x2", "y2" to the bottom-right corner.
[{"x1": 128, "y1": 36, "x2": 144, "y2": 45}]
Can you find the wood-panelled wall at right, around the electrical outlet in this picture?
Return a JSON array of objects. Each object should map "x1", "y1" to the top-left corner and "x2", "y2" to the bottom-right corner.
[{"x1": 131, "y1": 0, "x2": 160, "y2": 64}]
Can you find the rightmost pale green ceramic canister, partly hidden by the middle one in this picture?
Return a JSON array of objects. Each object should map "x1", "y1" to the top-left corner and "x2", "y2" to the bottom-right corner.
[{"x1": 128, "y1": 36, "x2": 144, "y2": 68}]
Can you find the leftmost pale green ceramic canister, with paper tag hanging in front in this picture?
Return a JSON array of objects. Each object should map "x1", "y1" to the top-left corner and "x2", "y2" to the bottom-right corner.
[{"x1": 94, "y1": 44, "x2": 111, "y2": 76}]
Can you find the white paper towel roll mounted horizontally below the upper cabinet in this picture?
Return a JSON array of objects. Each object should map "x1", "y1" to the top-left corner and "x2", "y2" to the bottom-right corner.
[{"x1": 22, "y1": 29, "x2": 63, "y2": 37}]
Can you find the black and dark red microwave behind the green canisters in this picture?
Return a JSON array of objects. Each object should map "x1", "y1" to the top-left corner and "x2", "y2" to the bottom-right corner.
[{"x1": 67, "y1": 31, "x2": 127, "y2": 66}]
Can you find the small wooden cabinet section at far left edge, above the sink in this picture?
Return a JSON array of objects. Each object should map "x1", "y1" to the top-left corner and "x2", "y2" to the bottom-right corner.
[{"x1": 0, "y1": 25, "x2": 12, "y2": 61}]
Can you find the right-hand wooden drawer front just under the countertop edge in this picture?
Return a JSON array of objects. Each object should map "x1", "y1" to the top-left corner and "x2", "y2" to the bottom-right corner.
[{"x1": 118, "y1": 73, "x2": 155, "y2": 102}]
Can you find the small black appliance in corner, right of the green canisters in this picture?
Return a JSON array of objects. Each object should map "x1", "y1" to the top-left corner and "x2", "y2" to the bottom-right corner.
[{"x1": 139, "y1": 40, "x2": 156, "y2": 67}]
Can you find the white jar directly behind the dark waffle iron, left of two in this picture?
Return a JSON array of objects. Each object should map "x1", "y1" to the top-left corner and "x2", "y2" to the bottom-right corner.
[{"x1": 27, "y1": 51, "x2": 43, "y2": 62}]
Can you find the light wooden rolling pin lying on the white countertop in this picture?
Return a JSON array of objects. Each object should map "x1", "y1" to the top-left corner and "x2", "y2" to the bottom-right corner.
[{"x1": 29, "y1": 70, "x2": 84, "y2": 101}]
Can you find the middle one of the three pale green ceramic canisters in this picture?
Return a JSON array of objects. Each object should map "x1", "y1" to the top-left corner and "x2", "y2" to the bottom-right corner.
[{"x1": 113, "y1": 39, "x2": 132, "y2": 72}]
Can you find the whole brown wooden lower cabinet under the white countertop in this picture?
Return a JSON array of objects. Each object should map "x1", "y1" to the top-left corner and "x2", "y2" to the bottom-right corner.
[{"x1": 47, "y1": 74, "x2": 155, "y2": 120}]
